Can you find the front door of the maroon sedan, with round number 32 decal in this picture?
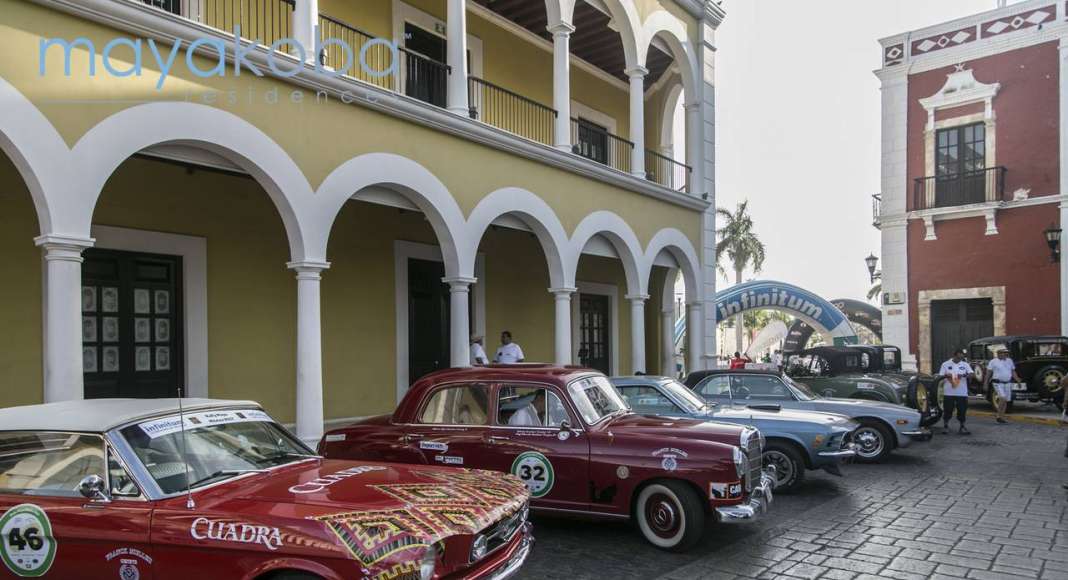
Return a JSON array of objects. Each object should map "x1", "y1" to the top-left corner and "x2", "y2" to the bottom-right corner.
[{"x1": 484, "y1": 383, "x2": 590, "y2": 511}]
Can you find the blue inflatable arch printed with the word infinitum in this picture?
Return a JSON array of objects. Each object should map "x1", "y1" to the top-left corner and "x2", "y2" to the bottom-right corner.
[{"x1": 716, "y1": 280, "x2": 860, "y2": 345}]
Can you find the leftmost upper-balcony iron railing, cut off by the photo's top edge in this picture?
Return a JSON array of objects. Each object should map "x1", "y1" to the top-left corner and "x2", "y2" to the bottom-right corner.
[{"x1": 141, "y1": 0, "x2": 295, "y2": 46}]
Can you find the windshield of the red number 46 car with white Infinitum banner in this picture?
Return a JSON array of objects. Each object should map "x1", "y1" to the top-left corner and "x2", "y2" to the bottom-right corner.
[{"x1": 122, "y1": 409, "x2": 315, "y2": 493}]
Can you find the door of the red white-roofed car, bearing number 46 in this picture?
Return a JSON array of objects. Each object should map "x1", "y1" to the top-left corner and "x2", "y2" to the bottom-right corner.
[{"x1": 0, "y1": 432, "x2": 153, "y2": 580}]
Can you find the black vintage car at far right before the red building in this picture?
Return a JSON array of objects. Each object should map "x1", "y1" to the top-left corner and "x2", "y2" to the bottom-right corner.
[{"x1": 968, "y1": 336, "x2": 1068, "y2": 407}]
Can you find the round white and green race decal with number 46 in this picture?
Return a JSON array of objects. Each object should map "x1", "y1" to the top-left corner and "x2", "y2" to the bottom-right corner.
[{"x1": 0, "y1": 503, "x2": 56, "y2": 578}]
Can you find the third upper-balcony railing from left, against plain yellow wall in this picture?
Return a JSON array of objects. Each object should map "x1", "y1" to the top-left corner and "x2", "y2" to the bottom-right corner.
[{"x1": 468, "y1": 76, "x2": 556, "y2": 145}]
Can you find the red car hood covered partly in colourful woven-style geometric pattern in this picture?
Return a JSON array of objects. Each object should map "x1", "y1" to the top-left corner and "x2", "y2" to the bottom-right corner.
[{"x1": 222, "y1": 459, "x2": 530, "y2": 577}]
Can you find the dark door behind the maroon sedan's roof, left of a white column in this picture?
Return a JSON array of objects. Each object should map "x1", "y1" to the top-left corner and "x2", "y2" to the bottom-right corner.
[{"x1": 408, "y1": 260, "x2": 450, "y2": 383}]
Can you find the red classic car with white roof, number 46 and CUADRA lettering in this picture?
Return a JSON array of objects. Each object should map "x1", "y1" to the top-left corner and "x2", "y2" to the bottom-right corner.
[{"x1": 0, "y1": 399, "x2": 532, "y2": 580}]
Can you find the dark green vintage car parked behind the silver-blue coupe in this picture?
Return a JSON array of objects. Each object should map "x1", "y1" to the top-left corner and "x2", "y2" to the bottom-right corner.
[{"x1": 786, "y1": 346, "x2": 942, "y2": 427}]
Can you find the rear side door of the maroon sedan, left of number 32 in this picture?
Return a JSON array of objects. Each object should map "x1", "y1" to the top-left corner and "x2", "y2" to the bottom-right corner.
[{"x1": 404, "y1": 382, "x2": 490, "y2": 469}]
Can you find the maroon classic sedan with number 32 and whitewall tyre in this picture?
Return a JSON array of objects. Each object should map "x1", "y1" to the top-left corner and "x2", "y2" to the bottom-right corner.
[{"x1": 319, "y1": 364, "x2": 773, "y2": 550}]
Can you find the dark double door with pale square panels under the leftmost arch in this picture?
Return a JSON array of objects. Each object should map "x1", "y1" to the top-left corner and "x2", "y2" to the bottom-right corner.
[{"x1": 81, "y1": 249, "x2": 184, "y2": 398}]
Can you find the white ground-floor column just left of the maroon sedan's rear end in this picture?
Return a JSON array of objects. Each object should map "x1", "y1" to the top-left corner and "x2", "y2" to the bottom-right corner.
[{"x1": 286, "y1": 262, "x2": 330, "y2": 445}]
